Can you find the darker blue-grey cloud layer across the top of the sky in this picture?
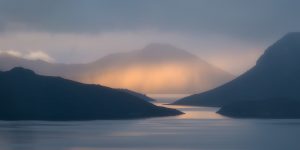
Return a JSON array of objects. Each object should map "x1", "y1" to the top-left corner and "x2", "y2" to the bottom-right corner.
[{"x1": 0, "y1": 0, "x2": 300, "y2": 41}]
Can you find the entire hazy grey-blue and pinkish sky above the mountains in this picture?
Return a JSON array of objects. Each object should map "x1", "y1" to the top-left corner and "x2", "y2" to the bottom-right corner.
[{"x1": 0, "y1": 0, "x2": 300, "y2": 74}]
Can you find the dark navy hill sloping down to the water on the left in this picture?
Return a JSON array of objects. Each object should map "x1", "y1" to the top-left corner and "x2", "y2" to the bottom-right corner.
[{"x1": 0, "y1": 68, "x2": 182, "y2": 121}]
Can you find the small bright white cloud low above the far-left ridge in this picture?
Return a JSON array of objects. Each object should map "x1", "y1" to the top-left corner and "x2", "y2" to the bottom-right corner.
[{"x1": 0, "y1": 50, "x2": 55, "y2": 62}]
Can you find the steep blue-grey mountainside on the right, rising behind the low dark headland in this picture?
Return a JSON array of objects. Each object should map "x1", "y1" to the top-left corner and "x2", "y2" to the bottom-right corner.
[{"x1": 174, "y1": 32, "x2": 300, "y2": 106}]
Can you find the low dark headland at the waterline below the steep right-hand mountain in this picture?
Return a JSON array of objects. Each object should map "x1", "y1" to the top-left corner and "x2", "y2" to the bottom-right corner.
[{"x1": 218, "y1": 98, "x2": 300, "y2": 119}]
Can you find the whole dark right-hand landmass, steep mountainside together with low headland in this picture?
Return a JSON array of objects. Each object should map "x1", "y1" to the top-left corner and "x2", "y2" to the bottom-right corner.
[{"x1": 174, "y1": 32, "x2": 300, "y2": 118}]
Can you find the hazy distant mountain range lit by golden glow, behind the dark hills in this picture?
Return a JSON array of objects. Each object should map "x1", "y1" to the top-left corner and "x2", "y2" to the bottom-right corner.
[{"x1": 0, "y1": 44, "x2": 234, "y2": 94}]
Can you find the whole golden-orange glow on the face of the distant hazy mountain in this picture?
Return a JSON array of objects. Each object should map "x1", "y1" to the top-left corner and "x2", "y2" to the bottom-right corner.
[{"x1": 79, "y1": 63, "x2": 232, "y2": 94}]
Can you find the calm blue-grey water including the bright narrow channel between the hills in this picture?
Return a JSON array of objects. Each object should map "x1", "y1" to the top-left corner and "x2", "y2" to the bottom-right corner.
[{"x1": 0, "y1": 94, "x2": 300, "y2": 150}]
